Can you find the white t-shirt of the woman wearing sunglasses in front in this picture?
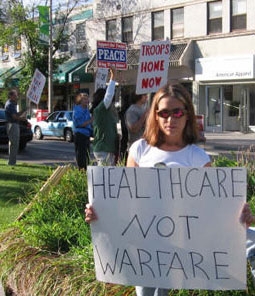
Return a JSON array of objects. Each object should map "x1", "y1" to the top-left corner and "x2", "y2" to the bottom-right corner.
[{"x1": 129, "y1": 139, "x2": 211, "y2": 167}]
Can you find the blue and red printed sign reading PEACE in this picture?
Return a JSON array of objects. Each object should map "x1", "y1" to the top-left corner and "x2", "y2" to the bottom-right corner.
[{"x1": 97, "y1": 41, "x2": 127, "y2": 70}]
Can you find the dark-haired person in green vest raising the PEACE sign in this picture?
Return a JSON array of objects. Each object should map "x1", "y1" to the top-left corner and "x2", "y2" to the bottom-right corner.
[{"x1": 90, "y1": 67, "x2": 118, "y2": 166}]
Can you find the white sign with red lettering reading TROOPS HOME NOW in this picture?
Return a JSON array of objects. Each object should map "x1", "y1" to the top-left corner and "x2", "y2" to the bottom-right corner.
[{"x1": 136, "y1": 41, "x2": 171, "y2": 94}]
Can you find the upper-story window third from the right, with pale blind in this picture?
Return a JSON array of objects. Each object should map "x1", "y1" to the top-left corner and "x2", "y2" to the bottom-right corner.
[{"x1": 171, "y1": 7, "x2": 184, "y2": 39}]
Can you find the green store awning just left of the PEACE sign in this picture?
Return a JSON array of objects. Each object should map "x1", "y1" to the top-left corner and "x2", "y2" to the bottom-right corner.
[{"x1": 53, "y1": 58, "x2": 91, "y2": 83}]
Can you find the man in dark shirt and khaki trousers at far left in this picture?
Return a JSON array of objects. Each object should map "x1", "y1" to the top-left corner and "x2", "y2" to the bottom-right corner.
[{"x1": 5, "y1": 89, "x2": 25, "y2": 165}]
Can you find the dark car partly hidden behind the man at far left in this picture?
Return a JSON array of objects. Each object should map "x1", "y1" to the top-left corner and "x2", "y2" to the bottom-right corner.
[{"x1": 0, "y1": 109, "x2": 33, "y2": 151}]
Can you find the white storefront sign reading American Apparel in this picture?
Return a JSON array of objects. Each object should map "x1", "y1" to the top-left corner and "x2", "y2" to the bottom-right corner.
[{"x1": 195, "y1": 55, "x2": 255, "y2": 81}]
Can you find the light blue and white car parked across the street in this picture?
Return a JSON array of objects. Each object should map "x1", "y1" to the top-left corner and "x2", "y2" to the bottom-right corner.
[{"x1": 32, "y1": 111, "x2": 74, "y2": 142}]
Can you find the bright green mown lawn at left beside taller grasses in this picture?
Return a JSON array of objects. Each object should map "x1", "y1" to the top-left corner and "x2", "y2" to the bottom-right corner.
[{"x1": 0, "y1": 159, "x2": 52, "y2": 231}]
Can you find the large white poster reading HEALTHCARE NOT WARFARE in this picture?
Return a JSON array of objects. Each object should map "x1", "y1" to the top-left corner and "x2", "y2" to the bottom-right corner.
[{"x1": 88, "y1": 166, "x2": 246, "y2": 290}]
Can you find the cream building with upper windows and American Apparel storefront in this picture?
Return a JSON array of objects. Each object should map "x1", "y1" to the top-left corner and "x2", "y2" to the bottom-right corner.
[{"x1": 86, "y1": 0, "x2": 255, "y2": 132}]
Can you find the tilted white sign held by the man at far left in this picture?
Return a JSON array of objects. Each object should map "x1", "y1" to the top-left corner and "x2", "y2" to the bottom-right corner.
[{"x1": 27, "y1": 69, "x2": 46, "y2": 104}]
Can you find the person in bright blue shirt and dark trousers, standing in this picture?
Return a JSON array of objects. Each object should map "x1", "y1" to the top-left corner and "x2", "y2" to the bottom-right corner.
[{"x1": 73, "y1": 93, "x2": 93, "y2": 170}]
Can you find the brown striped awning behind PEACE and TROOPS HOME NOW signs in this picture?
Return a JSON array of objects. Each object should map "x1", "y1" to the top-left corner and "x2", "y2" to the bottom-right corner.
[{"x1": 87, "y1": 42, "x2": 192, "y2": 72}]
